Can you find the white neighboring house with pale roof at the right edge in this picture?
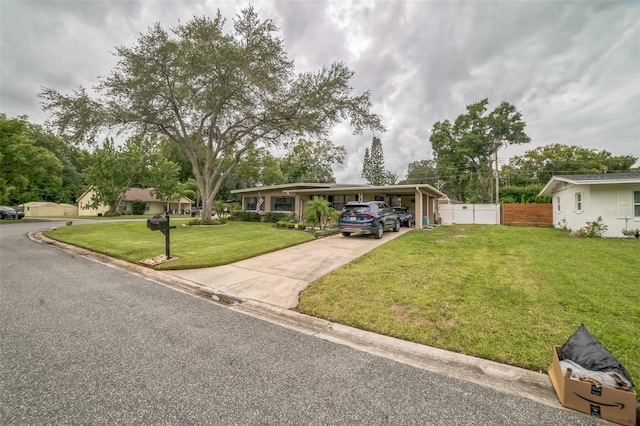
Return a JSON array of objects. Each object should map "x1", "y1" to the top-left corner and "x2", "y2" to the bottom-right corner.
[{"x1": 540, "y1": 173, "x2": 640, "y2": 237}]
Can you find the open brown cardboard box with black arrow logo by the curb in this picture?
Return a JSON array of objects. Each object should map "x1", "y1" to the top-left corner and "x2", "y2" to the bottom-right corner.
[{"x1": 549, "y1": 346, "x2": 636, "y2": 426}]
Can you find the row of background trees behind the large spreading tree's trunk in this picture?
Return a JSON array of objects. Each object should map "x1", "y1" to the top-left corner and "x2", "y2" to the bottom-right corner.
[{"x1": 0, "y1": 114, "x2": 346, "y2": 209}]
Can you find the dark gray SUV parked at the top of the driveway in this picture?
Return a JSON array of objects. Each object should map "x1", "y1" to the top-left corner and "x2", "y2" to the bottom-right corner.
[{"x1": 338, "y1": 201, "x2": 400, "y2": 238}]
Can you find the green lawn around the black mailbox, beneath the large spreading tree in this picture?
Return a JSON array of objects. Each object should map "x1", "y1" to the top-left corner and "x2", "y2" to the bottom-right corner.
[{"x1": 44, "y1": 220, "x2": 314, "y2": 269}]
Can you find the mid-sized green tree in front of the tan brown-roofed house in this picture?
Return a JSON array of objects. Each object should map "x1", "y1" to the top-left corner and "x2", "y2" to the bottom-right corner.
[{"x1": 80, "y1": 138, "x2": 179, "y2": 212}]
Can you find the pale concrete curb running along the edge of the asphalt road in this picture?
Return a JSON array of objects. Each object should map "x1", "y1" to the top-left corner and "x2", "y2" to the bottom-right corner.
[{"x1": 28, "y1": 231, "x2": 563, "y2": 408}]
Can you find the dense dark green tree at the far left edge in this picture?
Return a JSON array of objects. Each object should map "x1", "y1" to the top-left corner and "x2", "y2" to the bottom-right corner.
[{"x1": 0, "y1": 114, "x2": 63, "y2": 205}]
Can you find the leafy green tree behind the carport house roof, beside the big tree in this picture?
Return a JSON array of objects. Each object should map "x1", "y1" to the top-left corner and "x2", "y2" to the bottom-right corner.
[{"x1": 280, "y1": 139, "x2": 347, "y2": 183}]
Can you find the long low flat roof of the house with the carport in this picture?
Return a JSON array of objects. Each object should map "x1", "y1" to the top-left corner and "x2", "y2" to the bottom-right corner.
[{"x1": 231, "y1": 183, "x2": 445, "y2": 197}]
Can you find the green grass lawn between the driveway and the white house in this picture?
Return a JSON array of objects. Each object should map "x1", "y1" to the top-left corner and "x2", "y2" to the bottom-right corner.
[{"x1": 298, "y1": 225, "x2": 640, "y2": 383}]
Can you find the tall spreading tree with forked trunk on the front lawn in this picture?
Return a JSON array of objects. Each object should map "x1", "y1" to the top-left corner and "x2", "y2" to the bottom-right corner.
[{"x1": 40, "y1": 7, "x2": 384, "y2": 219}]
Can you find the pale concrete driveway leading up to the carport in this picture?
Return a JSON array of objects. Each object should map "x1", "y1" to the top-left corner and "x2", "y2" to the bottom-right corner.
[{"x1": 165, "y1": 228, "x2": 413, "y2": 309}]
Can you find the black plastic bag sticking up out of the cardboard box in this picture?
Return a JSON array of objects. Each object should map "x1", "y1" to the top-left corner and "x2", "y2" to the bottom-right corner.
[{"x1": 558, "y1": 324, "x2": 633, "y2": 386}]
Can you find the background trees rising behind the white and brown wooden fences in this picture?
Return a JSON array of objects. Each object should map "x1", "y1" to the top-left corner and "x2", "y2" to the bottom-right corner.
[{"x1": 400, "y1": 99, "x2": 640, "y2": 203}]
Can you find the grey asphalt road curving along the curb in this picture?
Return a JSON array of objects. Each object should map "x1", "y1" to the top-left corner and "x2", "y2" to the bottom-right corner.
[{"x1": 0, "y1": 223, "x2": 602, "y2": 425}]
